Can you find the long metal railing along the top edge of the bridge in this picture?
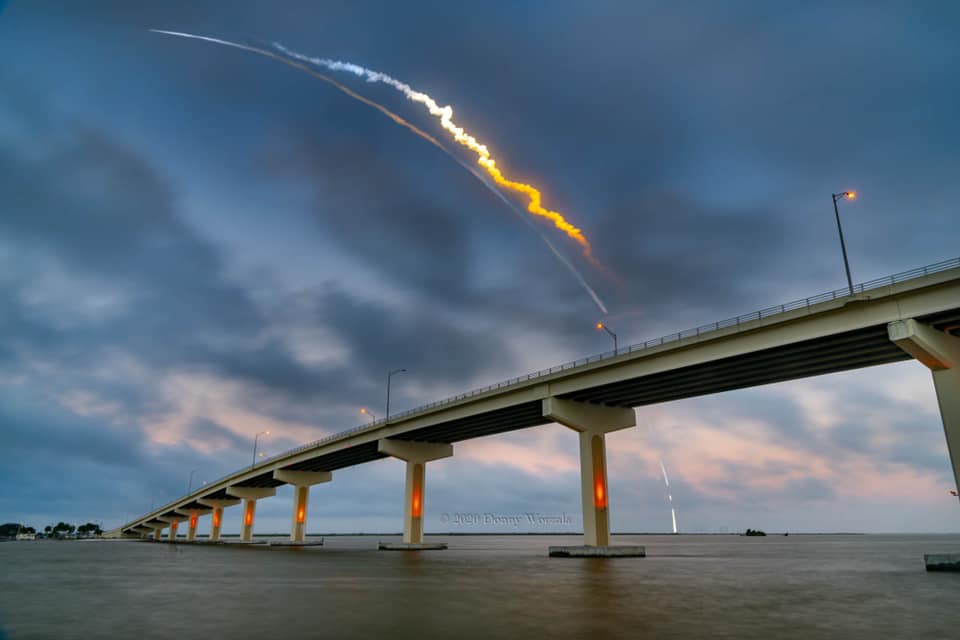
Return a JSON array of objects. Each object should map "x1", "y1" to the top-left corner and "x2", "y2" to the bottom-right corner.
[{"x1": 137, "y1": 257, "x2": 960, "y2": 524}]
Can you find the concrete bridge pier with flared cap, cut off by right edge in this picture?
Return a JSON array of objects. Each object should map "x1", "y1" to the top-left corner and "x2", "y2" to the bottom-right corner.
[{"x1": 887, "y1": 319, "x2": 960, "y2": 496}]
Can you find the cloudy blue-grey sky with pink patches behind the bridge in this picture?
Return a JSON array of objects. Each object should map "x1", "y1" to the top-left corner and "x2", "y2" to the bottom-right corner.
[{"x1": 0, "y1": 0, "x2": 960, "y2": 532}]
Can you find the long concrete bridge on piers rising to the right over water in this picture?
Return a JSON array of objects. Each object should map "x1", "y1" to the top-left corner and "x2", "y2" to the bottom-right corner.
[{"x1": 110, "y1": 258, "x2": 960, "y2": 548}]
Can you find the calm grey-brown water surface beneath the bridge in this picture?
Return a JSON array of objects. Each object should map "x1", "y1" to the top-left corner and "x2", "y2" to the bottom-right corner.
[{"x1": 0, "y1": 536, "x2": 960, "y2": 640}]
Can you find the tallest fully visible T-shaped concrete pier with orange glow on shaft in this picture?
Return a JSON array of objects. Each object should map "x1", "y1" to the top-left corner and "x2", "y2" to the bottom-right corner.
[{"x1": 543, "y1": 398, "x2": 637, "y2": 547}]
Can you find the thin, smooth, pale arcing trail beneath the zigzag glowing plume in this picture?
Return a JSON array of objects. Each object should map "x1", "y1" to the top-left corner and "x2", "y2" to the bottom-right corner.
[{"x1": 150, "y1": 29, "x2": 607, "y2": 314}]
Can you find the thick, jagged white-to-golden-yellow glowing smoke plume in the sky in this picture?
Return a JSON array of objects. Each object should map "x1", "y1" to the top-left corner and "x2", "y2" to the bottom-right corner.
[{"x1": 273, "y1": 42, "x2": 604, "y2": 270}]
